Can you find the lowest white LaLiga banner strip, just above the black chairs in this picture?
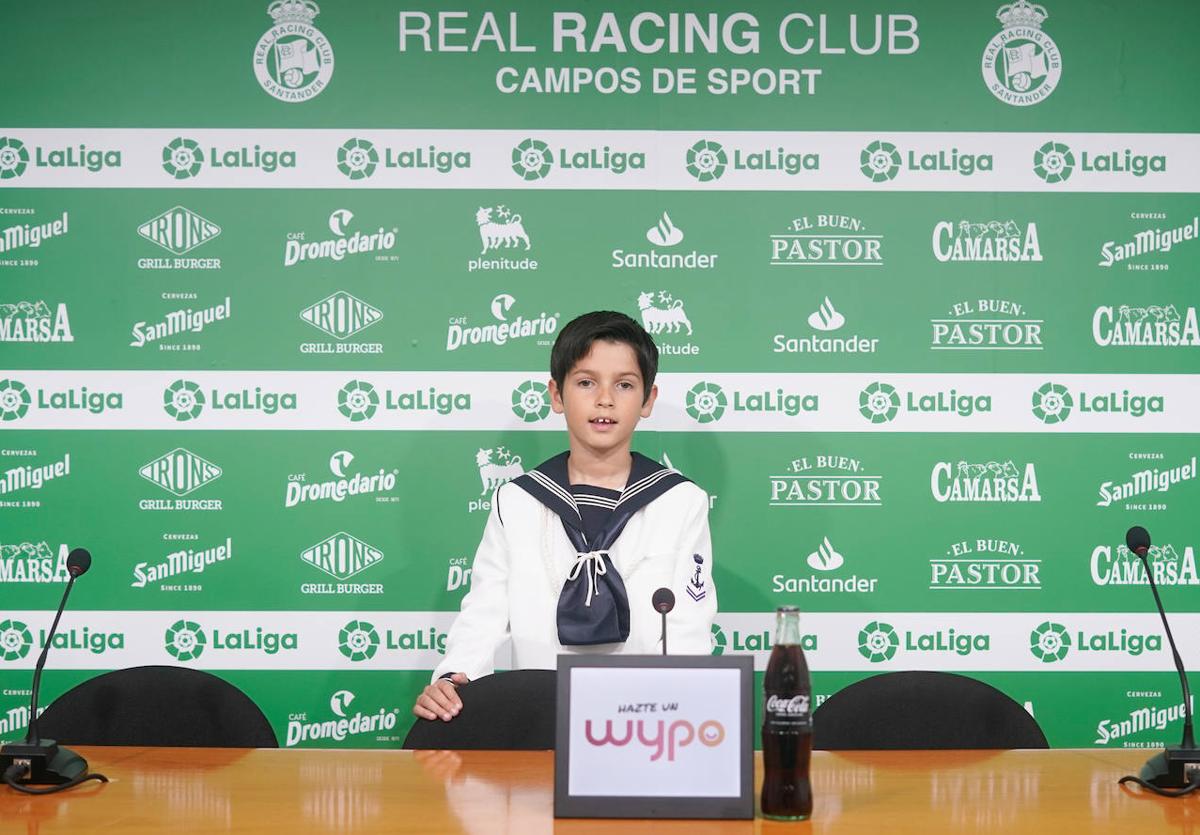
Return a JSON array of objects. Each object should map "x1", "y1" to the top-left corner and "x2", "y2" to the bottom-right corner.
[{"x1": 0, "y1": 611, "x2": 1200, "y2": 672}]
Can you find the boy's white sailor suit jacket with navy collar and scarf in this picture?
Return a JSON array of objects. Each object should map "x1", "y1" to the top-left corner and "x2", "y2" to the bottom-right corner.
[{"x1": 433, "y1": 452, "x2": 716, "y2": 679}]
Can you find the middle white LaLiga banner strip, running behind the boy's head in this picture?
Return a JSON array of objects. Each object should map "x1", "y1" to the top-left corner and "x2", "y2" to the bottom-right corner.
[{"x1": 0, "y1": 371, "x2": 1200, "y2": 433}]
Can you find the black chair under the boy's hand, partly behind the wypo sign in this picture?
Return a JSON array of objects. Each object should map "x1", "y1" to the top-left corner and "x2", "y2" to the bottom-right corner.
[{"x1": 404, "y1": 669, "x2": 558, "y2": 751}]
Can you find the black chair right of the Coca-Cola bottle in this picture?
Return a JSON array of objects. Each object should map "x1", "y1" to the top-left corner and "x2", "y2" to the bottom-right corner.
[{"x1": 812, "y1": 672, "x2": 1049, "y2": 751}]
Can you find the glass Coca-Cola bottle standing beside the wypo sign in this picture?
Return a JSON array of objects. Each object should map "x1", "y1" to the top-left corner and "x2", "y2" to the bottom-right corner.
[{"x1": 762, "y1": 606, "x2": 812, "y2": 821}]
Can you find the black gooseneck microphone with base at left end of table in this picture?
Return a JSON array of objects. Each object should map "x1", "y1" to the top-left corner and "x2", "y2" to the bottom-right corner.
[{"x1": 0, "y1": 548, "x2": 108, "y2": 794}]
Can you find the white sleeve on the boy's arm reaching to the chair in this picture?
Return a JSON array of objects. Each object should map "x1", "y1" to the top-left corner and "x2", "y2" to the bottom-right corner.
[{"x1": 433, "y1": 487, "x2": 509, "y2": 681}]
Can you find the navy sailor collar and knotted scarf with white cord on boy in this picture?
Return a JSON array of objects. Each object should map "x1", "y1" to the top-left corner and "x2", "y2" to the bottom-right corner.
[{"x1": 512, "y1": 452, "x2": 689, "y2": 645}]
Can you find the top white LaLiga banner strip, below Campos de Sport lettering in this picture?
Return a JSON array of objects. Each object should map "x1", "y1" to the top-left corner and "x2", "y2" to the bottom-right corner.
[{"x1": 0, "y1": 127, "x2": 1200, "y2": 193}]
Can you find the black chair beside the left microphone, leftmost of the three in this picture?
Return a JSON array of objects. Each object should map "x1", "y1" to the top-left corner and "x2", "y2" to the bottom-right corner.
[{"x1": 37, "y1": 667, "x2": 280, "y2": 747}]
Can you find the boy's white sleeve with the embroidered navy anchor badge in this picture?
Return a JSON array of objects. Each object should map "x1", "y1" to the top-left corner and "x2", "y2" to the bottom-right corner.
[{"x1": 667, "y1": 488, "x2": 716, "y2": 655}]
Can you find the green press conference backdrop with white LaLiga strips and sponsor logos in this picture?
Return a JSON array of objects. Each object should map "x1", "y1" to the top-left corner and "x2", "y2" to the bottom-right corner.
[{"x1": 0, "y1": 0, "x2": 1200, "y2": 747}]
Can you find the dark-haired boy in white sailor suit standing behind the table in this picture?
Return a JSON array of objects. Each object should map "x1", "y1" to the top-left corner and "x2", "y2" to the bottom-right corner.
[{"x1": 413, "y1": 311, "x2": 716, "y2": 721}]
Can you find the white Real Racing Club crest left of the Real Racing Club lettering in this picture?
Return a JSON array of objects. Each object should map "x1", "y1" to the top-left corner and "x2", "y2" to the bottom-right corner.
[{"x1": 254, "y1": 0, "x2": 334, "y2": 102}]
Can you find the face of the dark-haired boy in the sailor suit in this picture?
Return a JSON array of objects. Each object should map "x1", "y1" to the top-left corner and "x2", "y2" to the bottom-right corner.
[{"x1": 550, "y1": 340, "x2": 659, "y2": 452}]
